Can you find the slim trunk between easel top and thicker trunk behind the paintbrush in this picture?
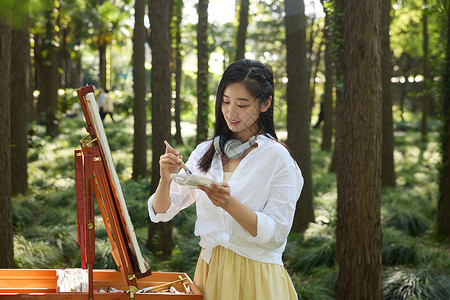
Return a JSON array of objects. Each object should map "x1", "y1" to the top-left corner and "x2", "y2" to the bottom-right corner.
[{"x1": 133, "y1": 0, "x2": 147, "y2": 179}]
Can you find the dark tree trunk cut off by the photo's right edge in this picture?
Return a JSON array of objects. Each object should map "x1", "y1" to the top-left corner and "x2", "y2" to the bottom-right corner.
[{"x1": 437, "y1": 0, "x2": 450, "y2": 238}]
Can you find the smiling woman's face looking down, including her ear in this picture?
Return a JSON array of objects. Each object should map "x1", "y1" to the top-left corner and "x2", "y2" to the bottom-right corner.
[{"x1": 221, "y1": 83, "x2": 272, "y2": 142}]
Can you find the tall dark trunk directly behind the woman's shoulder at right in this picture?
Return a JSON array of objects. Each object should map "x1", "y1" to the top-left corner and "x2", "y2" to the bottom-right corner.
[{"x1": 284, "y1": 0, "x2": 314, "y2": 232}]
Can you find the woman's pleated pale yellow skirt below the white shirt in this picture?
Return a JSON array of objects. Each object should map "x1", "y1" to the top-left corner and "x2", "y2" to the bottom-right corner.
[{"x1": 194, "y1": 246, "x2": 297, "y2": 300}]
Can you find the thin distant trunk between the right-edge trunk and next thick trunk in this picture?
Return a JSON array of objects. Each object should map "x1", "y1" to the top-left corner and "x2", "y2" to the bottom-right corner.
[{"x1": 420, "y1": 0, "x2": 432, "y2": 140}]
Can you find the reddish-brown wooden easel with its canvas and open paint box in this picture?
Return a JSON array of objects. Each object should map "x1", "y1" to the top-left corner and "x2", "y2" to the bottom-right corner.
[{"x1": 0, "y1": 86, "x2": 203, "y2": 300}]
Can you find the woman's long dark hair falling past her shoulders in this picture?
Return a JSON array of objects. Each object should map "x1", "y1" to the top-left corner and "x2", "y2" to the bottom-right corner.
[{"x1": 198, "y1": 59, "x2": 278, "y2": 172}]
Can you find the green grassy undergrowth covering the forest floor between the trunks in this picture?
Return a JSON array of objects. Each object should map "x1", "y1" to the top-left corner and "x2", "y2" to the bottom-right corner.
[{"x1": 13, "y1": 115, "x2": 450, "y2": 300}]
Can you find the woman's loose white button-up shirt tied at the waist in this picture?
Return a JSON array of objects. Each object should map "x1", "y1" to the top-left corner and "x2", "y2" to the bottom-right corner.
[{"x1": 148, "y1": 135, "x2": 303, "y2": 265}]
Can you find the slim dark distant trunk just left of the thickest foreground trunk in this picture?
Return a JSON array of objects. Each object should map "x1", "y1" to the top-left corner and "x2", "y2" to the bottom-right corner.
[{"x1": 321, "y1": 14, "x2": 333, "y2": 151}]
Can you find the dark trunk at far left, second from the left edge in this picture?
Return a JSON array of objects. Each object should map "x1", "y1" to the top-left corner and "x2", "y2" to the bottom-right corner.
[{"x1": 11, "y1": 1, "x2": 31, "y2": 195}]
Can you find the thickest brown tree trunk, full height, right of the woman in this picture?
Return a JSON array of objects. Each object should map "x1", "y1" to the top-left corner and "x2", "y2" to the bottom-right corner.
[{"x1": 336, "y1": 0, "x2": 382, "y2": 300}]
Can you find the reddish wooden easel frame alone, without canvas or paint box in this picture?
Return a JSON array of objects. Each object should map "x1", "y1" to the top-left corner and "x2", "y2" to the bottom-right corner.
[{"x1": 75, "y1": 86, "x2": 151, "y2": 299}]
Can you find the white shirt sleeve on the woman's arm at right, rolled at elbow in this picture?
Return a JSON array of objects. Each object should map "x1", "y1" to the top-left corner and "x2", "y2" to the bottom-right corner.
[{"x1": 247, "y1": 163, "x2": 303, "y2": 249}]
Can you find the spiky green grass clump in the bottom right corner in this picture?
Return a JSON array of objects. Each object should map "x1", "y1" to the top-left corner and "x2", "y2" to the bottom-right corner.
[{"x1": 383, "y1": 270, "x2": 450, "y2": 300}]
